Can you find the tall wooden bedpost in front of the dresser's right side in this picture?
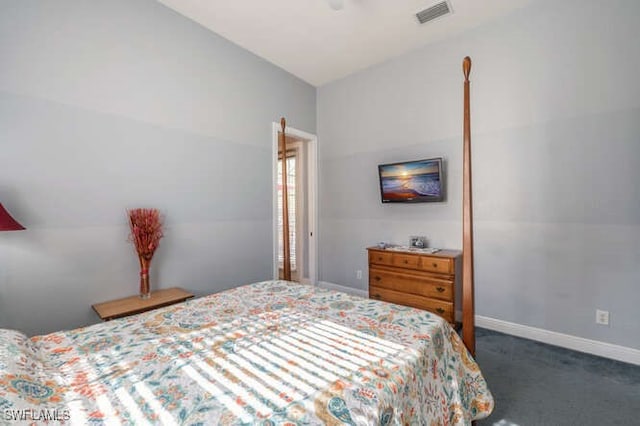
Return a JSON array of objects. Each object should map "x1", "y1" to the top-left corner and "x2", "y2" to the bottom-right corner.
[{"x1": 462, "y1": 56, "x2": 476, "y2": 356}]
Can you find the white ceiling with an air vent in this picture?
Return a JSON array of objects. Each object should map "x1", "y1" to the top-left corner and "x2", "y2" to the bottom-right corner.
[{"x1": 158, "y1": 0, "x2": 533, "y2": 86}]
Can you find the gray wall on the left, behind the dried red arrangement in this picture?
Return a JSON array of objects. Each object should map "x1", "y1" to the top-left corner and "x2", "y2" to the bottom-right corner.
[{"x1": 0, "y1": 0, "x2": 316, "y2": 334}]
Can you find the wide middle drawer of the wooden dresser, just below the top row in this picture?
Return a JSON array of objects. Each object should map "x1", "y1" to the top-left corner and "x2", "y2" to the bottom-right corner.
[{"x1": 369, "y1": 268, "x2": 453, "y2": 302}]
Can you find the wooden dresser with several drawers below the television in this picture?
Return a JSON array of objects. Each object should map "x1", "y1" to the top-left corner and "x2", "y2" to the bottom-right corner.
[{"x1": 367, "y1": 247, "x2": 461, "y2": 324}]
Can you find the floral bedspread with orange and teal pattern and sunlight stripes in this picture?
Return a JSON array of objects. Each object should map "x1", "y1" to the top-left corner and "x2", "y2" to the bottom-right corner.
[{"x1": 0, "y1": 281, "x2": 493, "y2": 425}]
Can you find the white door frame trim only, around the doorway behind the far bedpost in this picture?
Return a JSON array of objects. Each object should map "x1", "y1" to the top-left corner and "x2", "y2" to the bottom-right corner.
[{"x1": 271, "y1": 122, "x2": 318, "y2": 285}]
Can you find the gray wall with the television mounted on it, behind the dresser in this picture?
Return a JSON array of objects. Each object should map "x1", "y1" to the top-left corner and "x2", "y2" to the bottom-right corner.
[{"x1": 318, "y1": 0, "x2": 640, "y2": 349}]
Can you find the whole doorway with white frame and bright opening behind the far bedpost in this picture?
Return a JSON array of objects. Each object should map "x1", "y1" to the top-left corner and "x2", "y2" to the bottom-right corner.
[{"x1": 273, "y1": 123, "x2": 317, "y2": 284}]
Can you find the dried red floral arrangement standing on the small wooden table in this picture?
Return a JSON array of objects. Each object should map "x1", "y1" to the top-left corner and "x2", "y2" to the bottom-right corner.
[{"x1": 128, "y1": 209, "x2": 164, "y2": 299}]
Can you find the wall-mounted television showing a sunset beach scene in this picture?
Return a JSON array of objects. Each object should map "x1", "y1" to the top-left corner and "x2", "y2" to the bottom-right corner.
[{"x1": 378, "y1": 158, "x2": 444, "y2": 203}]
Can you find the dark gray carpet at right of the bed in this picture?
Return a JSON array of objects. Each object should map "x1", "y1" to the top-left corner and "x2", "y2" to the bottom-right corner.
[{"x1": 476, "y1": 328, "x2": 640, "y2": 426}]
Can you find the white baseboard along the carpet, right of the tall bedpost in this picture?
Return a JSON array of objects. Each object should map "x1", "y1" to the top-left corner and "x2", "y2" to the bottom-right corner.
[{"x1": 476, "y1": 315, "x2": 640, "y2": 365}]
